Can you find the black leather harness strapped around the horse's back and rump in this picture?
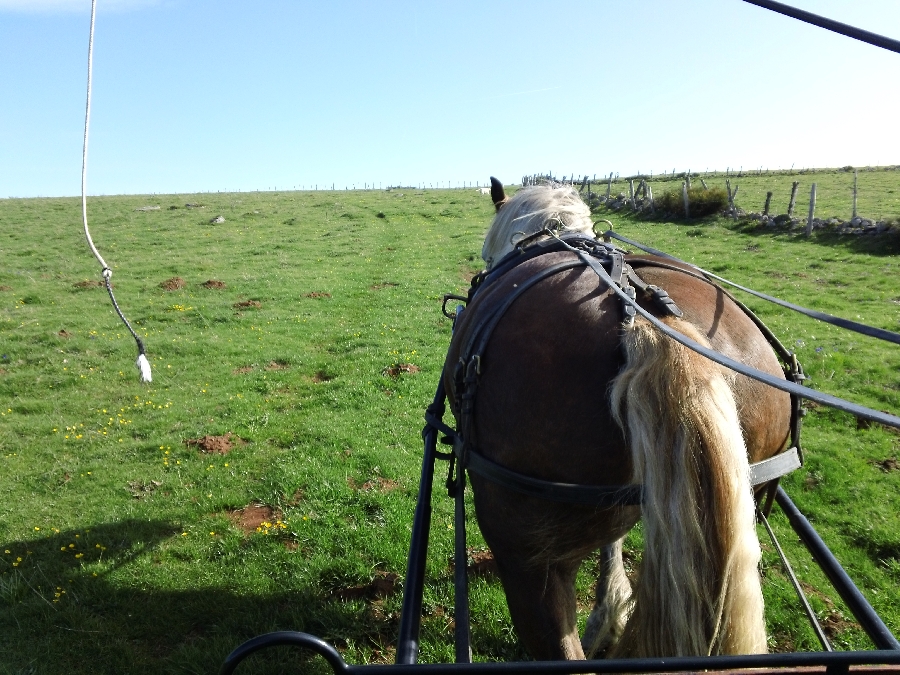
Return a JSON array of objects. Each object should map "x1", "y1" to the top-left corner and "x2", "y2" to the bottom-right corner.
[{"x1": 425, "y1": 235, "x2": 804, "y2": 507}]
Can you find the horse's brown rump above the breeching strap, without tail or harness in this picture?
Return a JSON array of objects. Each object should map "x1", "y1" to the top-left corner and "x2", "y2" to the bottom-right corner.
[{"x1": 444, "y1": 252, "x2": 790, "y2": 485}]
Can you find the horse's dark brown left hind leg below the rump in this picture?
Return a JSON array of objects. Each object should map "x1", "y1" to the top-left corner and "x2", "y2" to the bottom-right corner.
[{"x1": 494, "y1": 550, "x2": 584, "y2": 661}]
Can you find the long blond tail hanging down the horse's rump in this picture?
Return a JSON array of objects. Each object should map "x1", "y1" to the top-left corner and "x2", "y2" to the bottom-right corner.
[{"x1": 610, "y1": 319, "x2": 766, "y2": 657}]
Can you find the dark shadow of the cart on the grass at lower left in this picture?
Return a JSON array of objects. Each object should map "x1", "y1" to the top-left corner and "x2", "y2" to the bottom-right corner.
[{"x1": 0, "y1": 520, "x2": 408, "y2": 673}]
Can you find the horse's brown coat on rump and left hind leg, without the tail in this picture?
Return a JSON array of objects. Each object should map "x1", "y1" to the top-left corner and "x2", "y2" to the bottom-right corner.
[{"x1": 444, "y1": 251, "x2": 790, "y2": 659}]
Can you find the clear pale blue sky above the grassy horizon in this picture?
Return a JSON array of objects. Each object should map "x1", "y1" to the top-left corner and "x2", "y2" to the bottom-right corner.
[{"x1": 0, "y1": 0, "x2": 900, "y2": 197}]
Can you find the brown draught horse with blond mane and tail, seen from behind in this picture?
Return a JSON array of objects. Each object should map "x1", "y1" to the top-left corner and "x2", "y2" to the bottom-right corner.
[{"x1": 443, "y1": 178, "x2": 790, "y2": 660}]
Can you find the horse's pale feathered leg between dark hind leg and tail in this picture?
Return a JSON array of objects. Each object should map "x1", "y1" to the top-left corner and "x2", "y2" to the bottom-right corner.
[{"x1": 581, "y1": 539, "x2": 631, "y2": 659}]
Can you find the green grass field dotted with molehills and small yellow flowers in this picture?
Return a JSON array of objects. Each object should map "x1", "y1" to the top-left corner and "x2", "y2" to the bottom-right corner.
[{"x1": 0, "y1": 172, "x2": 900, "y2": 673}]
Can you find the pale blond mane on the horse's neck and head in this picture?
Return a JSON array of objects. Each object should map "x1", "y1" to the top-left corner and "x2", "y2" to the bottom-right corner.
[{"x1": 481, "y1": 184, "x2": 593, "y2": 269}]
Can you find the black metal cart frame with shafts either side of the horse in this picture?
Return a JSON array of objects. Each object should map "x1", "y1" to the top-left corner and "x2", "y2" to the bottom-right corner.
[{"x1": 220, "y1": 240, "x2": 900, "y2": 675}]
